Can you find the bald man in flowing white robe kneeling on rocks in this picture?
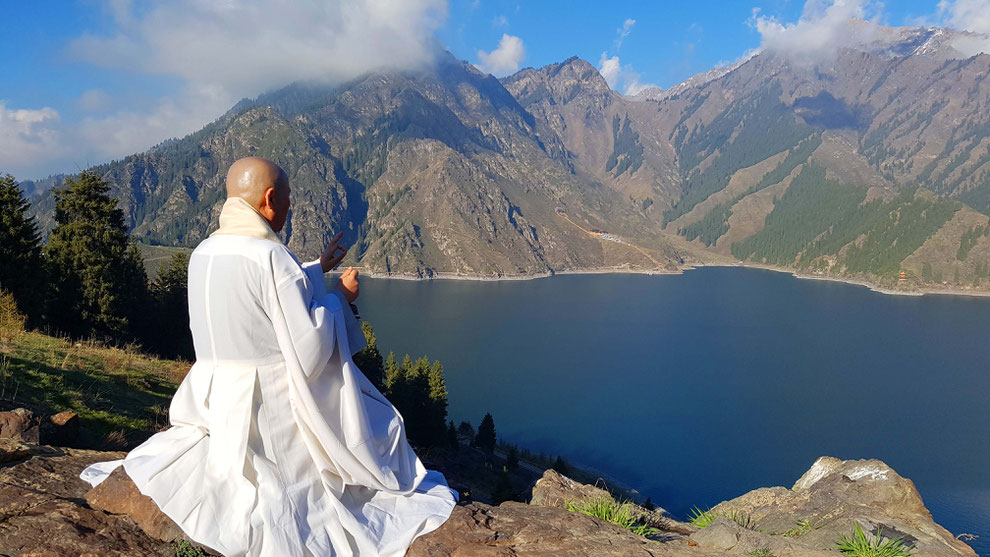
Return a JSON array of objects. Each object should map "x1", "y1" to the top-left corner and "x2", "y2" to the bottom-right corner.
[{"x1": 81, "y1": 157, "x2": 458, "y2": 557}]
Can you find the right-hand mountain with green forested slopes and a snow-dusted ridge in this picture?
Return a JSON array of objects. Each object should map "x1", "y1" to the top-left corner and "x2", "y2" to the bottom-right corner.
[{"x1": 503, "y1": 21, "x2": 990, "y2": 287}]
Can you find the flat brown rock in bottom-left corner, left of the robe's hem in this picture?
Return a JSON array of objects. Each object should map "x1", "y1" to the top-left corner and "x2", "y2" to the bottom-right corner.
[{"x1": 0, "y1": 446, "x2": 175, "y2": 557}]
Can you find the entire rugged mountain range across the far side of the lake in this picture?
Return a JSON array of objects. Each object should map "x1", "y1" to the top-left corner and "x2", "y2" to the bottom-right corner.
[{"x1": 27, "y1": 21, "x2": 990, "y2": 289}]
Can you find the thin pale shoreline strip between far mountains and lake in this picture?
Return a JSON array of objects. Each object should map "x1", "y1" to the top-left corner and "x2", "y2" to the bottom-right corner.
[{"x1": 342, "y1": 263, "x2": 990, "y2": 297}]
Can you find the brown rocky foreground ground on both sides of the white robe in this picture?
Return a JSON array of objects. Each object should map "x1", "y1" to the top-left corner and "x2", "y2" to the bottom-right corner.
[{"x1": 0, "y1": 404, "x2": 976, "y2": 557}]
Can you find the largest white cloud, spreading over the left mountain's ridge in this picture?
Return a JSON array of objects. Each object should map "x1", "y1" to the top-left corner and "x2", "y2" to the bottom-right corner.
[{"x1": 0, "y1": 0, "x2": 450, "y2": 175}]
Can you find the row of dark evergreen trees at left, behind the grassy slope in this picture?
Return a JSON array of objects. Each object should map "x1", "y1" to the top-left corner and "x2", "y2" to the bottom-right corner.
[{"x1": 0, "y1": 171, "x2": 193, "y2": 359}]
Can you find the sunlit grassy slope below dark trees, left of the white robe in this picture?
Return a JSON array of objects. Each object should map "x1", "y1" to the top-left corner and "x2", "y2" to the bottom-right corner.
[{"x1": 0, "y1": 332, "x2": 189, "y2": 449}]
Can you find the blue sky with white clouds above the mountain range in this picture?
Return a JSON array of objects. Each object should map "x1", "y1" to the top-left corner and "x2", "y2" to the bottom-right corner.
[{"x1": 0, "y1": 0, "x2": 976, "y2": 178}]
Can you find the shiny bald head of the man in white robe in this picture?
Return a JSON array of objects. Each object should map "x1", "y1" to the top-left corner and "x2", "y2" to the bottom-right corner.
[{"x1": 227, "y1": 157, "x2": 289, "y2": 232}]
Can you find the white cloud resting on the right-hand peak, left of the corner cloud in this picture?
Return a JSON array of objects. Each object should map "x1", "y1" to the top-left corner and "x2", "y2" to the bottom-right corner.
[{"x1": 747, "y1": 0, "x2": 882, "y2": 63}]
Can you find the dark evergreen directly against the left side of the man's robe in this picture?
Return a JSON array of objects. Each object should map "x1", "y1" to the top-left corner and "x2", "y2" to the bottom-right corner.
[{"x1": 145, "y1": 253, "x2": 196, "y2": 360}]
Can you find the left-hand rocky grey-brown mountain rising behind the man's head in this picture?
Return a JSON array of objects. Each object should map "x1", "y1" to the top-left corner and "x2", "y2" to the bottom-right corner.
[{"x1": 29, "y1": 51, "x2": 681, "y2": 276}]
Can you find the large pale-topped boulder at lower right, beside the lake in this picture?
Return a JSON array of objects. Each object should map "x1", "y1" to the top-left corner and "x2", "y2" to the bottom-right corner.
[{"x1": 713, "y1": 457, "x2": 976, "y2": 557}]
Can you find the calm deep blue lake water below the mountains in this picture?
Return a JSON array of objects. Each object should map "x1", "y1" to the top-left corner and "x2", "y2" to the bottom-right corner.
[{"x1": 358, "y1": 267, "x2": 990, "y2": 555}]
